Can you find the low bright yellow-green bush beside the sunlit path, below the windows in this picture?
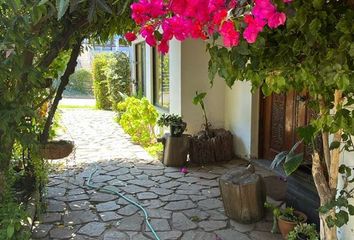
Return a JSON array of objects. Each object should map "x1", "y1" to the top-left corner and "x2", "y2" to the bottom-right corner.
[{"x1": 117, "y1": 97, "x2": 158, "y2": 147}]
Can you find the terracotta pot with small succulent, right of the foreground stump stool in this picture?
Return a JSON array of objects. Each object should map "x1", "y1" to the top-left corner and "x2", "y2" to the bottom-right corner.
[{"x1": 265, "y1": 203, "x2": 307, "y2": 239}]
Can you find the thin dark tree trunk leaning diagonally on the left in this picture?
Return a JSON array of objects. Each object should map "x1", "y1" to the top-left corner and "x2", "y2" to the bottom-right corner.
[{"x1": 40, "y1": 38, "x2": 83, "y2": 143}]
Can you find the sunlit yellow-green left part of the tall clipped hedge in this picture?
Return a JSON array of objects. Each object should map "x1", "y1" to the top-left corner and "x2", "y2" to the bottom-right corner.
[{"x1": 92, "y1": 53, "x2": 113, "y2": 109}]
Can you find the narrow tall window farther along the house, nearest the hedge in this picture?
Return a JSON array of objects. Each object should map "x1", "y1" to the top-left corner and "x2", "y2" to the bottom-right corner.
[{"x1": 135, "y1": 42, "x2": 146, "y2": 97}]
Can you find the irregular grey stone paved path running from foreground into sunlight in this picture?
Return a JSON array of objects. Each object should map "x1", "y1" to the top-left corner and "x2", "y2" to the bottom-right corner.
[{"x1": 32, "y1": 110, "x2": 281, "y2": 240}]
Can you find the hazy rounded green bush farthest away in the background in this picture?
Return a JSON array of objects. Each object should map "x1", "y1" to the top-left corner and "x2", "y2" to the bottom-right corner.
[{"x1": 68, "y1": 68, "x2": 92, "y2": 94}]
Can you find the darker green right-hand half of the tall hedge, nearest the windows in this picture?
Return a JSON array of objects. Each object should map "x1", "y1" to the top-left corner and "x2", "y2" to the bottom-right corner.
[{"x1": 106, "y1": 52, "x2": 131, "y2": 110}]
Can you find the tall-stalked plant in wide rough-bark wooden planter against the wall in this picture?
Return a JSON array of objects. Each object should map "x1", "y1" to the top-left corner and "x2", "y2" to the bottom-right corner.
[{"x1": 189, "y1": 92, "x2": 234, "y2": 163}]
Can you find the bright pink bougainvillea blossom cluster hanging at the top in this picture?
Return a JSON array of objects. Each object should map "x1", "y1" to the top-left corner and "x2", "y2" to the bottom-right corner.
[{"x1": 125, "y1": 0, "x2": 292, "y2": 53}]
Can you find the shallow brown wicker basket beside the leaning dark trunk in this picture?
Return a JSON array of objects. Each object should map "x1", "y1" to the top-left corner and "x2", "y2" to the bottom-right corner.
[{"x1": 40, "y1": 140, "x2": 74, "y2": 159}]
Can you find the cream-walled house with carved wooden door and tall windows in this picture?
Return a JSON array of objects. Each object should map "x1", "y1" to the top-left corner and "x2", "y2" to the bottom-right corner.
[{"x1": 132, "y1": 38, "x2": 354, "y2": 239}]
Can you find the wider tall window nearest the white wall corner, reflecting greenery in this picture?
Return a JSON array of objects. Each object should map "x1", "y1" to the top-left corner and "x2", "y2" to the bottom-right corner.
[{"x1": 153, "y1": 48, "x2": 170, "y2": 109}]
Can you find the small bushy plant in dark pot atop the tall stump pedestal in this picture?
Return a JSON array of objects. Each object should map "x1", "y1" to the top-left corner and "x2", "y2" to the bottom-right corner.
[{"x1": 157, "y1": 114, "x2": 187, "y2": 137}]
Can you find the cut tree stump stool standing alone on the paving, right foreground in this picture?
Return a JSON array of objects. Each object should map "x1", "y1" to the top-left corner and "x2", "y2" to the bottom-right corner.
[{"x1": 219, "y1": 165, "x2": 266, "y2": 223}]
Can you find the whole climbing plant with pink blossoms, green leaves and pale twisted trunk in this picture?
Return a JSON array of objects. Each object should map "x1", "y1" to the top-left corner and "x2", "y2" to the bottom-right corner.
[{"x1": 126, "y1": 0, "x2": 354, "y2": 240}]
